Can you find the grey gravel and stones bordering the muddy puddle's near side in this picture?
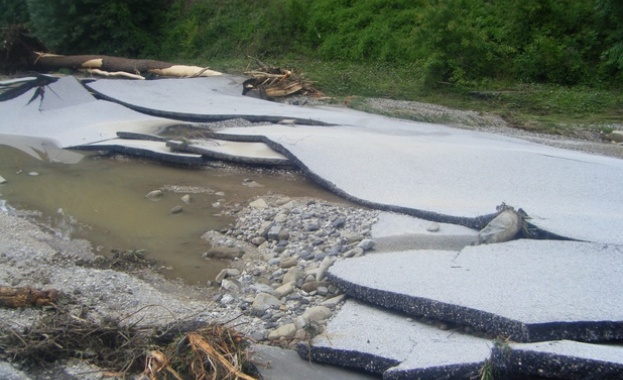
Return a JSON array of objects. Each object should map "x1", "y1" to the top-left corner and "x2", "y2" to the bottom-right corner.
[{"x1": 0, "y1": 195, "x2": 377, "y2": 378}]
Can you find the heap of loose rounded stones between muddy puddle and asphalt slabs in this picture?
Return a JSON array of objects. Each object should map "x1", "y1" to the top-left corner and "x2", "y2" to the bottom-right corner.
[{"x1": 203, "y1": 196, "x2": 378, "y2": 347}]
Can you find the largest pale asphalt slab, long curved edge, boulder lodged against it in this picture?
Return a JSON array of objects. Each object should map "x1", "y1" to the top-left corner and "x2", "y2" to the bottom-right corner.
[{"x1": 221, "y1": 123, "x2": 623, "y2": 244}]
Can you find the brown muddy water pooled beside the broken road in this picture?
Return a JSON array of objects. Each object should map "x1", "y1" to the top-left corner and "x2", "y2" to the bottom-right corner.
[{"x1": 0, "y1": 145, "x2": 342, "y2": 283}]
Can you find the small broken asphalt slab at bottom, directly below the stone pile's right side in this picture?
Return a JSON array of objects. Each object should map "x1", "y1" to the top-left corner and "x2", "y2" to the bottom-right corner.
[{"x1": 298, "y1": 300, "x2": 493, "y2": 380}]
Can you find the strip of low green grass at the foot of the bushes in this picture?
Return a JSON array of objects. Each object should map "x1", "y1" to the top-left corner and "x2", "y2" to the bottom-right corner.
[{"x1": 197, "y1": 57, "x2": 623, "y2": 139}]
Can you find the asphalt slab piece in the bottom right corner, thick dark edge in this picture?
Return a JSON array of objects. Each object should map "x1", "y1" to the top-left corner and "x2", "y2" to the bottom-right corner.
[{"x1": 491, "y1": 340, "x2": 623, "y2": 379}]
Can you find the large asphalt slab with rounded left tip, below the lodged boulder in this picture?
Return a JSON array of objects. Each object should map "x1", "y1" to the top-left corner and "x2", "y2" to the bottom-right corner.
[{"x1": 328, "y1": 240, "x2": 623, "y2": 342}]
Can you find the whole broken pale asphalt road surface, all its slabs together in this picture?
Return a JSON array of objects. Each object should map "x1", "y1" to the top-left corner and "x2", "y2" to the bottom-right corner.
[{"x1": 0, "y1": 76, "x2": 623, "y2": 379}]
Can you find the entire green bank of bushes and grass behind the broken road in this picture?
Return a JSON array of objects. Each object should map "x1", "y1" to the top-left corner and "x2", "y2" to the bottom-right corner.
[{"x1": 0, "y1": 0, "x2": 623, "y2": 133}]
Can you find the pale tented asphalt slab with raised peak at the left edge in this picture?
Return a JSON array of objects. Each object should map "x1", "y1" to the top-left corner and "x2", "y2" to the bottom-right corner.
[{"x1": 0, "y1": 76, "x2": 177, "y2": 161}]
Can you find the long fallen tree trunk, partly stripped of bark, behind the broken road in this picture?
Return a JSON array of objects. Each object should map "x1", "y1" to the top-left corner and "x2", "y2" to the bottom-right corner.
[{"x1": 33, "y1": 52, "x2": 221, "y2": 78}]
